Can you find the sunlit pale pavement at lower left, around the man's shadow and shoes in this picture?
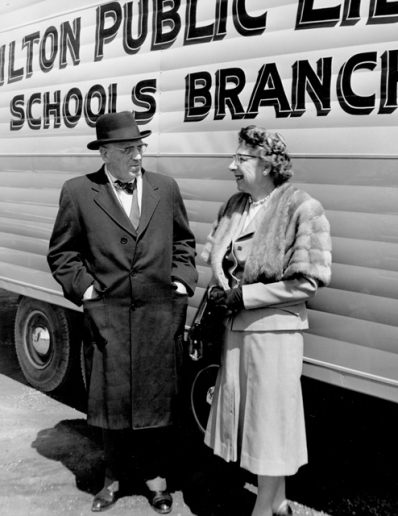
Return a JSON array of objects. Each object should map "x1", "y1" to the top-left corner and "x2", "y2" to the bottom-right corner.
[{"x1": 0, "y1": 364, "x2": 197, "y2": 516}]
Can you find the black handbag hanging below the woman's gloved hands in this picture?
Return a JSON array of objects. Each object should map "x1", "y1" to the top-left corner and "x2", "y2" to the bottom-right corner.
[{"x1": 187, "y1": 287, "x2": 225, "y2": 363}]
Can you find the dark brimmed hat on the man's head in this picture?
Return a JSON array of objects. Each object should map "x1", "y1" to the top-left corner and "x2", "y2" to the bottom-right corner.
[{"x1": 87, "y1": 111, "x2": 152, "y2": 150}]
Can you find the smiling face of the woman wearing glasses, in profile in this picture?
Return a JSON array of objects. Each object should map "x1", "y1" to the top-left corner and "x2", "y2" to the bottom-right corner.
[{"x1": 229, "y1": 142, "x2": 269, "y2": 197}]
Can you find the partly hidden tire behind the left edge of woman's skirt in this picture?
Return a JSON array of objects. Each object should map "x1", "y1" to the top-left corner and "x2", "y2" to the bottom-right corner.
[{"x1": 191, "y1": 364, "x2": 220, "y2": 434}]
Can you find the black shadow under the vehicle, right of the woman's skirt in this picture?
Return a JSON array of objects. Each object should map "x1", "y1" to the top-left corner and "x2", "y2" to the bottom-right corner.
[{"x1": 288, "y1": 378, "x2": 398, "y2": 516}]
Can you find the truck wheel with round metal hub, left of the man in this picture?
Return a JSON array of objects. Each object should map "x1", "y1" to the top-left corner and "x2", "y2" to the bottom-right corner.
[{"x1": 15, "y1": 297, "x2": 80, "y2": 392}]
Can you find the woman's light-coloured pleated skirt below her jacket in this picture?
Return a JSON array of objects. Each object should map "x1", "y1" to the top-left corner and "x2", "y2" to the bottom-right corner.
[{"x1": 205, "y1": 330, "x2": 308, "y2": 476}]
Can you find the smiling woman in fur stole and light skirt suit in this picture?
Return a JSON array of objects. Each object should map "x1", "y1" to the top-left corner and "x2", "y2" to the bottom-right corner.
[{"x1": 202, "y1": 125, "x2": 331, "y2": 516}]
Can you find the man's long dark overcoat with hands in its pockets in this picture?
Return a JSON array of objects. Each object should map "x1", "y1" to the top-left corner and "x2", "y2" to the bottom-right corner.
[{"x1": 48, "y1": 167, "x2": 197, "y2": 430}]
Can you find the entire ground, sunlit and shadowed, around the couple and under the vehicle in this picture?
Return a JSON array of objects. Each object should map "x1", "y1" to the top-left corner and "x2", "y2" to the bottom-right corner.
[{"x1": 0, "y1": 289, "x2": 398, "y2": 516}]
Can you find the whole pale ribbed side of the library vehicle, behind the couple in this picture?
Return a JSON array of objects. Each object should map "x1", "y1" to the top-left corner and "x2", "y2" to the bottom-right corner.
[{"x1": 0, "y1": 0, "x2": 398, "y2": 401}]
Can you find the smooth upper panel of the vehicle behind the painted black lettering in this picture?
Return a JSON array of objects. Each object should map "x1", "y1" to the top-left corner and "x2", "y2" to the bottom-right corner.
[{"x1": 0, "y1": 0, "x2": 398, "y2": 156}]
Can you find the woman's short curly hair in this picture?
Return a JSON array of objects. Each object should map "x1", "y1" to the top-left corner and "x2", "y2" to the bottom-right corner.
[{"x1": 239, "y1": 125, "x2": 294, "y2": 186}]
